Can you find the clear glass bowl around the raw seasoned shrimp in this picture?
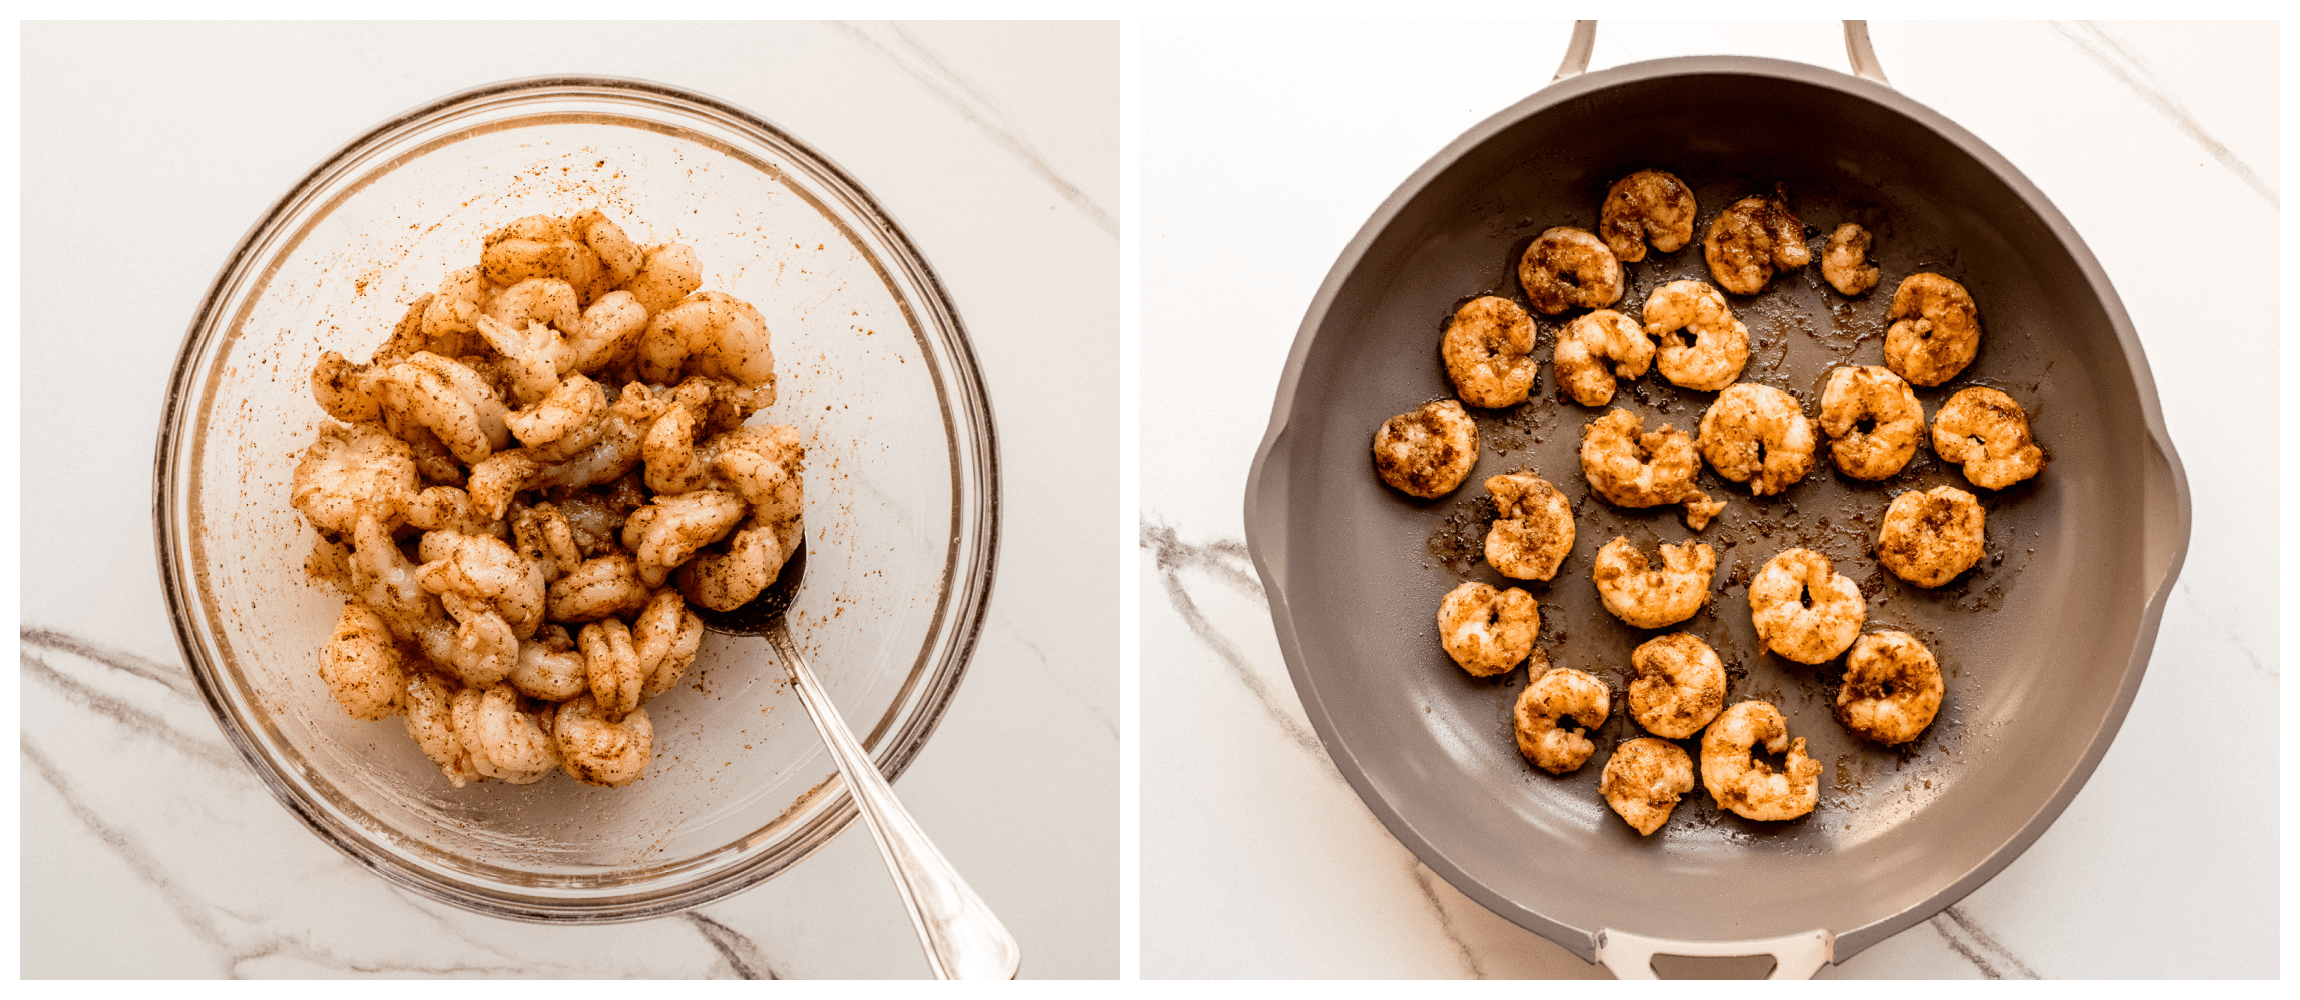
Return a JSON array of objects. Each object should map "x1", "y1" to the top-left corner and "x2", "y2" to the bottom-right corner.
[{"x1": 154, "y1": 78, "x2": 998, "y2": 922}]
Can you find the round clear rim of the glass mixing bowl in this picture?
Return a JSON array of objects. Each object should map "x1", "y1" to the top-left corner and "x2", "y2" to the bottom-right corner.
[{"x1": 152, "y1": 74, "x2": 1003, "y2": 922}]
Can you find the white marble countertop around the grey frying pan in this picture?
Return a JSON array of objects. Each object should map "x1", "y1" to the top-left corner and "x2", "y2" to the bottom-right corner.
[{"x1": 1139, "y1": 23, "x2": 2279, "y2": 979}]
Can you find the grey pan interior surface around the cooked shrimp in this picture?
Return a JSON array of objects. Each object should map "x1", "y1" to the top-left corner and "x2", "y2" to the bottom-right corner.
[{"x1": 1247, "y1": 57, "x2": 2190, "y2": 974}]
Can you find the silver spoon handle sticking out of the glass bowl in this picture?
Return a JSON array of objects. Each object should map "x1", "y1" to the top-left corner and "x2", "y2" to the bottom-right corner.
[{"x1": 766, "y1": 616, "x2": 1021, "y2": 979}]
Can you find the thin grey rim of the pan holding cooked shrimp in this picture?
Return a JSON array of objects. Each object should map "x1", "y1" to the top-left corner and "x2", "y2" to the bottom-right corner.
[{"x1": 1244, "y1": 55, "x2": 2192, "y2": 963}]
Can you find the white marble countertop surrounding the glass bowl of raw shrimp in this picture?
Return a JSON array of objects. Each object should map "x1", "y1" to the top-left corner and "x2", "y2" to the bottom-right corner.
[{"x1": 21, "y1": 23, "x2": 1118, "y2": 977}]
